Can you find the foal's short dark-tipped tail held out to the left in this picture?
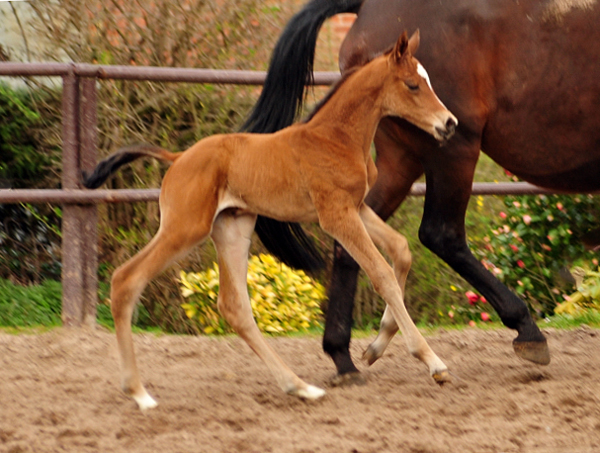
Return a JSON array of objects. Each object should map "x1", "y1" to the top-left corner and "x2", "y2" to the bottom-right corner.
[{"x1": 83, "y1": 143, "x2": 181, "y2": 189}]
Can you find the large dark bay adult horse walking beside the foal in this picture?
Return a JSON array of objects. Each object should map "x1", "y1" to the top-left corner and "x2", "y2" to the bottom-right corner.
[{"x1": 249, "y1": 0, "x2": 600, "y2": 384}]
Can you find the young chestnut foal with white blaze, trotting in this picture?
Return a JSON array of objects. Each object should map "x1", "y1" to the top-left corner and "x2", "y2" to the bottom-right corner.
[{"x1": 84, "y1": 31, "x2": 457, "y2": 409}]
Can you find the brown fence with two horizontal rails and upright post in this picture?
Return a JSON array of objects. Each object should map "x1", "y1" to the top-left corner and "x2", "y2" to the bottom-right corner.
[{"x1": 0, "y1": 63, "x2": 592, "y2": 326}]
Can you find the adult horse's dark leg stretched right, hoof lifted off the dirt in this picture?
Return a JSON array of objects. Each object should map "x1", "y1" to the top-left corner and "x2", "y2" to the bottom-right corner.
[{"x1": 419, "y1": 144, "x2": 550, "y2": 365}]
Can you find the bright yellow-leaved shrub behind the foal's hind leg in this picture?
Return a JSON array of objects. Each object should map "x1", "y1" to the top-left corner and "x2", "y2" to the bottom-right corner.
[{"x1": 180, "y1": 254, "x2": 325, "y2": 334}]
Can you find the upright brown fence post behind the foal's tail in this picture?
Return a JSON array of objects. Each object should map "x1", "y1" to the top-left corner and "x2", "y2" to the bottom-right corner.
[{"x1": 62, "y1": 71, "x2": 98, "y2": 326}]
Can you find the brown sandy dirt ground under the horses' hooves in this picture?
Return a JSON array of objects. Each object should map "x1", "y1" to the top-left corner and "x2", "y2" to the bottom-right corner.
[{"x1": 0, "y1": 328, "x2": 600, "y2": 453}]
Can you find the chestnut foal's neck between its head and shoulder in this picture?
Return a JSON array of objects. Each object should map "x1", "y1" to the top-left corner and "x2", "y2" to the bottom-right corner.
[{"x1": 307, "y1": 59, "x2": 387, "y2": 152}]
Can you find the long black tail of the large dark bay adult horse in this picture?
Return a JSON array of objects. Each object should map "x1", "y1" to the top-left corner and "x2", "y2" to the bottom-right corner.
[{"x1": 241, "y1": 0, "x2": 363, "y2": 271}]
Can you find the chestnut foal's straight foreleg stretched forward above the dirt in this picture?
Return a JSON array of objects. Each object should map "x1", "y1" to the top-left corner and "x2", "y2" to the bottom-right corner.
[{"x1": 318, "y1": 200, "x2": 448, "y2": 383}]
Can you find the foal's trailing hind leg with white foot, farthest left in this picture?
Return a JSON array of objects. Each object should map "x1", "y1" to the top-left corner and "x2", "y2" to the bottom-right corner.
[{"x1": 111, "y1": 222, "x2": 210, "y2": 410}]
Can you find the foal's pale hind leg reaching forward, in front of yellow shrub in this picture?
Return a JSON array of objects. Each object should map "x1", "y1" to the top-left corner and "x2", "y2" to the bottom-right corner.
[{"x1": 212, "y1": 211, "x2": 325, "y2": 399}]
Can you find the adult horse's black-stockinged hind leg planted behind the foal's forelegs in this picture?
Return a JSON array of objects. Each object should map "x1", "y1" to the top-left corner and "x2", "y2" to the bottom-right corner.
[{"x1": 323, "y1": 118, "x2": 423, "y2": 385}]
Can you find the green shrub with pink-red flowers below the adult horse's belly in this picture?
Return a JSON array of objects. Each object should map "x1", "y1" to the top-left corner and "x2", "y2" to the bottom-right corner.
[{"x1": 480, "y1": 195, "x2": 599, "y2": 316}]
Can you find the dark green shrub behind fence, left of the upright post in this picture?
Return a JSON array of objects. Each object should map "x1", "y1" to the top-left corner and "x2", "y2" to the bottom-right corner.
[{"x1": 0, "y1": 82, "x2": 60, "y2": 283}]
